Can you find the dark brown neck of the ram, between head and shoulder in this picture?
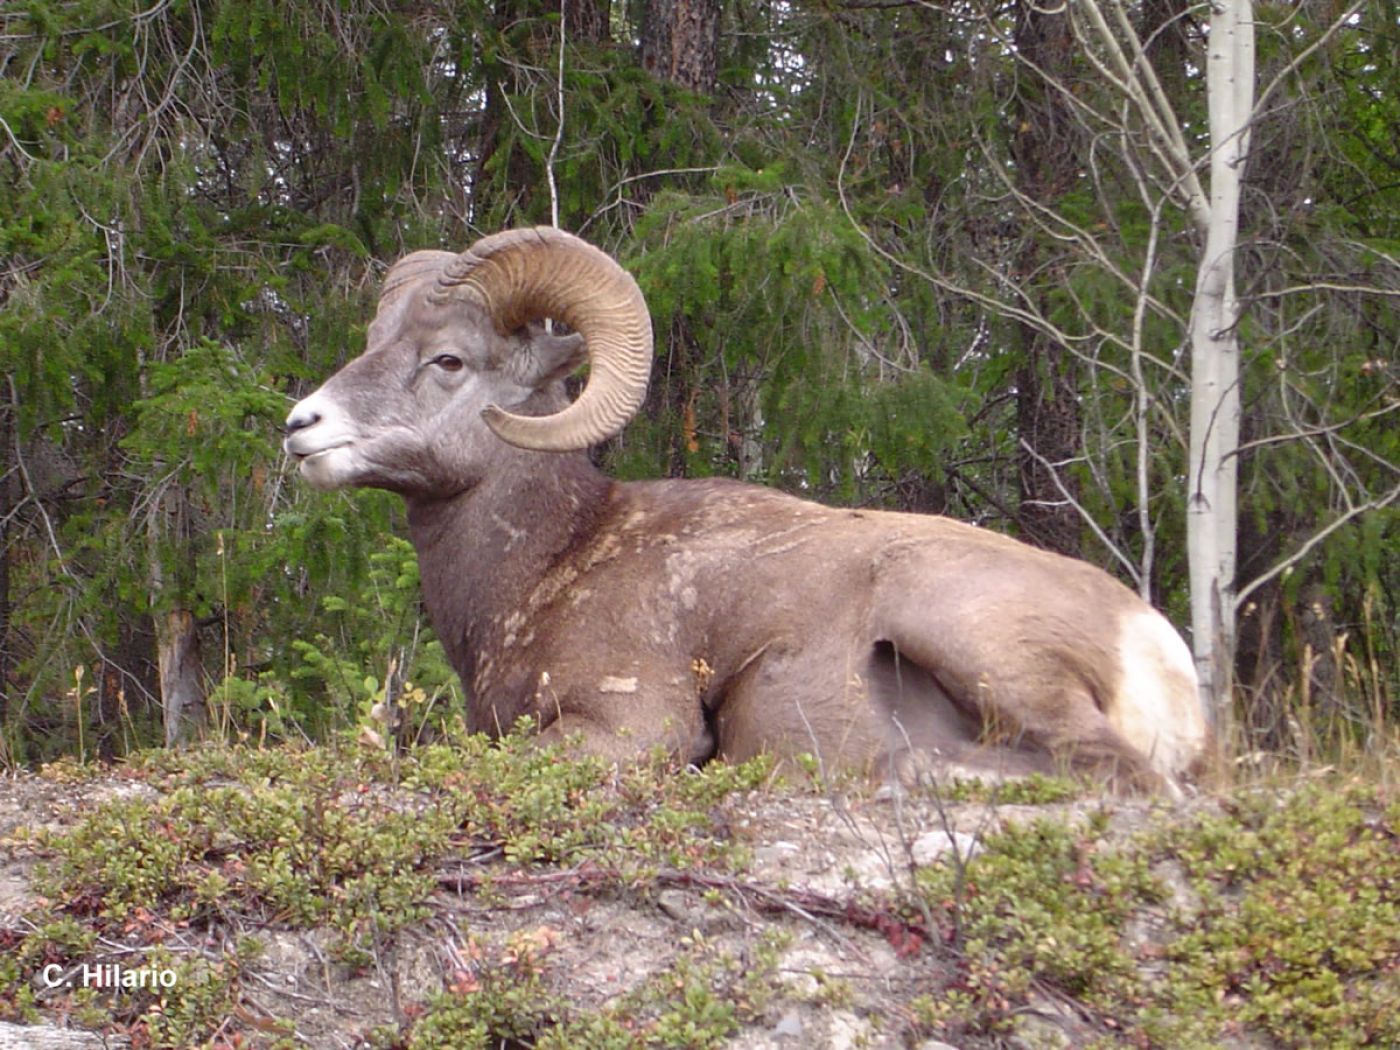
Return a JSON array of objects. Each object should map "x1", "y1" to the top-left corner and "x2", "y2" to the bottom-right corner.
[{"x1": 407, "y1": 452, "x2": 613, "y2": 687}]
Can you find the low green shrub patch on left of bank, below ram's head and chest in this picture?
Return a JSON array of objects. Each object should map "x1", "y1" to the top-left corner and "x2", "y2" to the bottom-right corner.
[{"x1": 0, "y1": 736, "x2": 770, "y2": 1047}]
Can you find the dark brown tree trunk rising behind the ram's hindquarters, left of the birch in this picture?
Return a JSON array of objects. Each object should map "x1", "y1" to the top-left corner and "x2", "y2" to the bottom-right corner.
[{"x1": 1011, "y1": 1, "x2": 1084, "y2": 556}]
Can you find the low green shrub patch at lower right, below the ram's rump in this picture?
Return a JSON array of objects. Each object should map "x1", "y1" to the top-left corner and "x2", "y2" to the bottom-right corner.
[{"x1": 916, "y1": 783, "x2": 1400, "y2": 1050}]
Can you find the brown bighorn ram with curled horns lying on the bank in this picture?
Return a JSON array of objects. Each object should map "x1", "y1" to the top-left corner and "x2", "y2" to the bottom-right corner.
[{"x1": 286, "y1": 228, "x2": 1207, "y2": 794}]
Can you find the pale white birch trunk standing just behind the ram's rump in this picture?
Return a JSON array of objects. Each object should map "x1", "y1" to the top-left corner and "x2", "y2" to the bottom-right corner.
[{"x1": 1186, "y1": 0, "x2": 1254, "y2": 736}]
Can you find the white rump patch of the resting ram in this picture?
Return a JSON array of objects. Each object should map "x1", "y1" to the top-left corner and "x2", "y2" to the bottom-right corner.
[{"x1": 1107, "y1": 609, "x2": 1205, "y2": 773}]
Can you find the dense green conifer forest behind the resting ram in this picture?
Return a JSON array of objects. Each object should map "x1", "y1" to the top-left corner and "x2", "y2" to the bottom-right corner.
[{"x1": 0, "y1": 0, "x2": 1400, "y2": 766}]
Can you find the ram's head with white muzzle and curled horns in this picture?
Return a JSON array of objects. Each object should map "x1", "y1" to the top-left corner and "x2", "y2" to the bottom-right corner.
[{"x1": 286, "y1": 227, "x2": 652, "y2": 496}]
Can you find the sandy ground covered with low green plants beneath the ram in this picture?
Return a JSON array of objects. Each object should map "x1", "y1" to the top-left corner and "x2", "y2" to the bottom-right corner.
[{"x1": 0, "y1": 738, "x2": 1400, "y2": 1050}]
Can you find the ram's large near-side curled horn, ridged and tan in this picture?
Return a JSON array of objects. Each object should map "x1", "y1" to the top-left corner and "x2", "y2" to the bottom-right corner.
[{"x1": 435, "y1": 227, "x2": 652, "y2": 452}]
